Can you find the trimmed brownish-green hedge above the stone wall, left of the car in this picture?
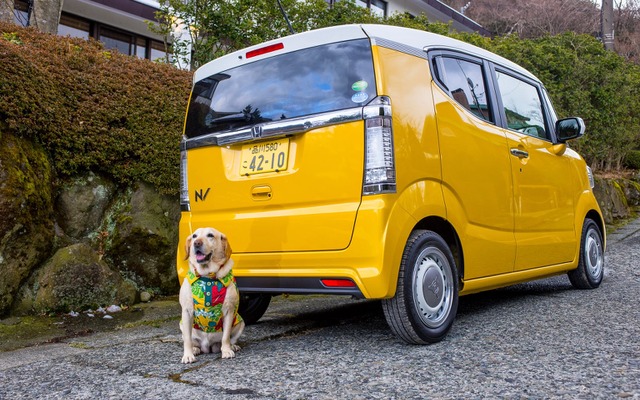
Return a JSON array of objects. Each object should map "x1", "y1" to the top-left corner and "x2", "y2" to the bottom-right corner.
[{"x1": 0, "y1": 24, "x2": 191, "y2": 193}]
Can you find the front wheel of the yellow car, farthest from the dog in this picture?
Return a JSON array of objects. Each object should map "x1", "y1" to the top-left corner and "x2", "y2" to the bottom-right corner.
[{"x1": 567, "y1": 218, "x2": 604, "y2": 289}]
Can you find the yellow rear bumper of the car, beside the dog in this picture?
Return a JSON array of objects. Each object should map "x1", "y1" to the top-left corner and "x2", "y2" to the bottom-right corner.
[{"x1": 177, "y1": 195, "x2": 415, "y2": 299}]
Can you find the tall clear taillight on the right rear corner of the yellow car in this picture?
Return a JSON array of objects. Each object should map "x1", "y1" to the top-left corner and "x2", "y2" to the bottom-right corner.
[{"x1": 362, "y1": 96, "x2": 396, "y2": 195}]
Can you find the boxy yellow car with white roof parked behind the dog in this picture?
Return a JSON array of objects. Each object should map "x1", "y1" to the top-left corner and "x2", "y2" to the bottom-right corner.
[{"x1": 177, "y1": 25, "x2": 605, "y2": 343}]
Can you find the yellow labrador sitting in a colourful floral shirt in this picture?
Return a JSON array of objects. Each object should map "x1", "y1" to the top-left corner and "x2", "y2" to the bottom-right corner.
[{"x1": 180, "y1": 228, "x2": 244, "y2": 363}]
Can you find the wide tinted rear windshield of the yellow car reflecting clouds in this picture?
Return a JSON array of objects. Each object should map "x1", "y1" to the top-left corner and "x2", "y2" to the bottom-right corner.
[{"x1": 185, "y1": 39, "x2": 376, "y2": 138}]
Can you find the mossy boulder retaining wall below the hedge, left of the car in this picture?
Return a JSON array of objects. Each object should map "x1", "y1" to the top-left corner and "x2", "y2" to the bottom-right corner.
[{"x1": 0, "y1": 134, "x2": 180, "y2": 316}]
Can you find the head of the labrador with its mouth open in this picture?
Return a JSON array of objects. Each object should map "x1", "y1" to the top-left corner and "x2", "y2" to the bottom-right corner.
[{"x1": 185, "y1": 228, "x2": 231, "y2": 274}]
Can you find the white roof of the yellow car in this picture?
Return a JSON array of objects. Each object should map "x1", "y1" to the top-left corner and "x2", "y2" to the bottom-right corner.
[{"x1": 193, "y1": 24, "x2": 538, "y2": 82}]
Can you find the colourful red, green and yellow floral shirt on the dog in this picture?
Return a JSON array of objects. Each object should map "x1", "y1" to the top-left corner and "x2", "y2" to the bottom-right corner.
[{"x1": 187, "y1": 271, "x2": 242, "y2": 333}]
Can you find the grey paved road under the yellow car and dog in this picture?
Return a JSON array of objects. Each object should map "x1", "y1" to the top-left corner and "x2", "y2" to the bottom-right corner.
[{"x1": 0, "y1": 221, "x2": 640, "y2": 399}]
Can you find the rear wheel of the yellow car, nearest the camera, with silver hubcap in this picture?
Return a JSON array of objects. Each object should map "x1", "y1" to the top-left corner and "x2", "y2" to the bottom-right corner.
[{"x1": 382, "y1": 230, "x2": 458, "y2": 344}]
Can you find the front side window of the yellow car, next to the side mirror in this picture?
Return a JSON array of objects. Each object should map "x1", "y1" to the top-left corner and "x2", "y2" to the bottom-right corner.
[{"x1": 496, "y1": 71, "x2": 549, "y2": 140}]
